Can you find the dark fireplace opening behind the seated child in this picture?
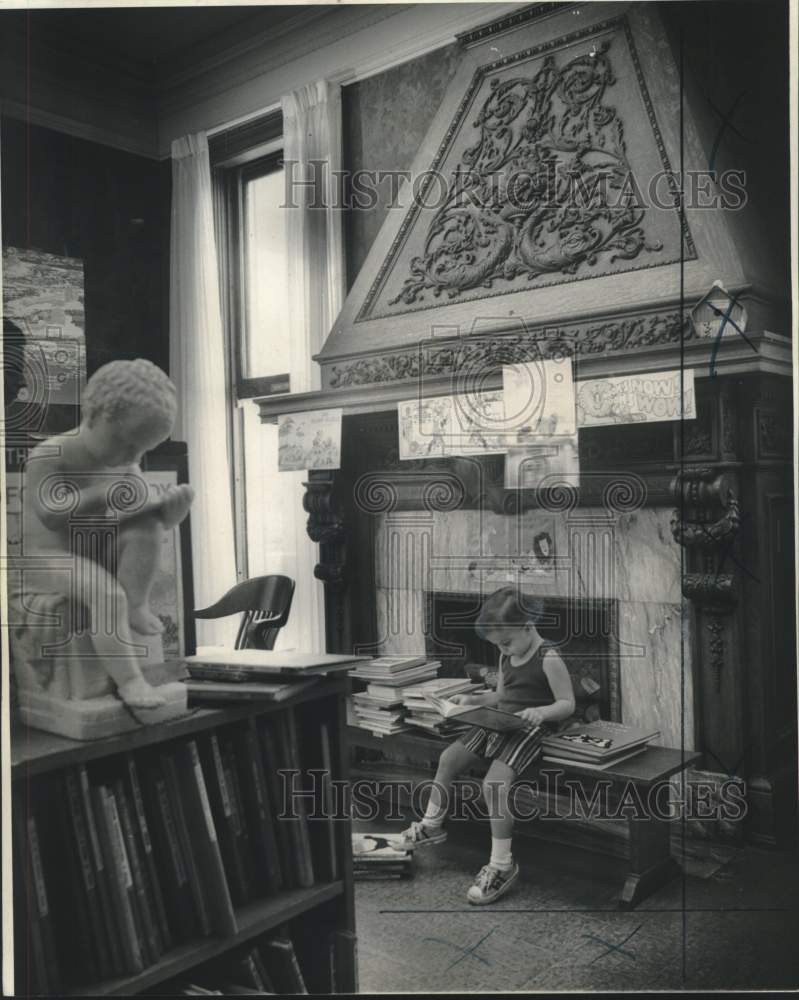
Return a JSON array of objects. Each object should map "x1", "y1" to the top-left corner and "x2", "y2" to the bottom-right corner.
[{"x1": 425, "y1": 591, "x2": 621, "y2": 722}]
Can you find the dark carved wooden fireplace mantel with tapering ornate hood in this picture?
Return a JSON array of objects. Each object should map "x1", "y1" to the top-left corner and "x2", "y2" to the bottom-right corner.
[{"x1": 276, "y1": 2, "x2": 796, "y2": 842}]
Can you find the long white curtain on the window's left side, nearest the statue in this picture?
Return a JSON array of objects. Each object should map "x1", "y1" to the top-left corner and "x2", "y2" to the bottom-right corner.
[{"x1": 169, "y1": 132, "x2": 238, "y2": 647}]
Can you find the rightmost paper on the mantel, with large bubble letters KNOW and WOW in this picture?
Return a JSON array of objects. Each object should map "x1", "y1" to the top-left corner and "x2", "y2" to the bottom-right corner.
[{"x1": 577, "y1": 368, "x2": 696, "y2": 427}]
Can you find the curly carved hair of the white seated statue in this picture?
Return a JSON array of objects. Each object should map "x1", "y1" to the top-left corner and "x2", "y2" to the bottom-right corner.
[{"x1": 82, "y1": 358, "x2": 178, "y2": 426}]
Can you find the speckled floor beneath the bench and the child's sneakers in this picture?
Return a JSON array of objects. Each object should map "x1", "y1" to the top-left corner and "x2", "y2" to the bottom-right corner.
[{"x1": 356, "y1": 822, "x2": 799, "y2": 993}]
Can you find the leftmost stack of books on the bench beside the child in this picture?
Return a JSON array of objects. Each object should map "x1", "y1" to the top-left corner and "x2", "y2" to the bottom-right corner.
[{"x1": 350, "y1": 655, "x2": 441, "y2": 736}]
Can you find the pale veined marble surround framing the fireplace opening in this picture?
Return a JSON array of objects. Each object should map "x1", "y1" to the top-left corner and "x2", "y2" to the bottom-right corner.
[{"x1": 373, "y1": 507, "x2": 694, "y2": 749}]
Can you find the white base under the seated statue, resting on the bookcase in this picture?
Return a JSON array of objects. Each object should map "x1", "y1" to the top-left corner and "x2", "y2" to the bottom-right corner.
[{"x1": 18, "y1": 635, "x2": 188, "y2": 740}]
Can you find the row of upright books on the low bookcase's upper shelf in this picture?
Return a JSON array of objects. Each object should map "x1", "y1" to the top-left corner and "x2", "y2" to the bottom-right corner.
[{"x1": 12, "y1": 709, "x2": 338, "y2": 993}]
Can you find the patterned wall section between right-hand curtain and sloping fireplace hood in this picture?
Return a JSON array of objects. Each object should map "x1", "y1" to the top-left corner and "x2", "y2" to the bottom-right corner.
[{"x1": 341, "y1": 44, "x2": 461, "y2": 288}]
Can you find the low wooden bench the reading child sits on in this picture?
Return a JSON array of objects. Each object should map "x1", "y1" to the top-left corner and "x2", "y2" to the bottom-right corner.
[{"x1": 347, "y1": 726, "x2": 701, "y2": 909}]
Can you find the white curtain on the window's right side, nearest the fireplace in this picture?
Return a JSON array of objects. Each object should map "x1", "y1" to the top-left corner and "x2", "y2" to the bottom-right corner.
[{"x1": 253, "y1": 80, "x2": 346, "y2": 652}]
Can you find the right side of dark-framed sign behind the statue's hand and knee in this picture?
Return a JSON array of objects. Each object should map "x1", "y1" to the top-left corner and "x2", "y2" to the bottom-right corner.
[{"x1": 142, "y1": 441, "x2": 197, "y2": 660}]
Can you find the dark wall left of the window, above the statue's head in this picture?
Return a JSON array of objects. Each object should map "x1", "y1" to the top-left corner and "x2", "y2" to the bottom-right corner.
[{"x1": 1, "y1": 118, "x2": 171, "y2": 374}]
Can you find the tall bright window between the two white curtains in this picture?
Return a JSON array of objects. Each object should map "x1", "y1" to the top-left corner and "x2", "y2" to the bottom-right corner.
[{"x1": 209, "y1": 120, "x2": 304, "y2": 616}]
